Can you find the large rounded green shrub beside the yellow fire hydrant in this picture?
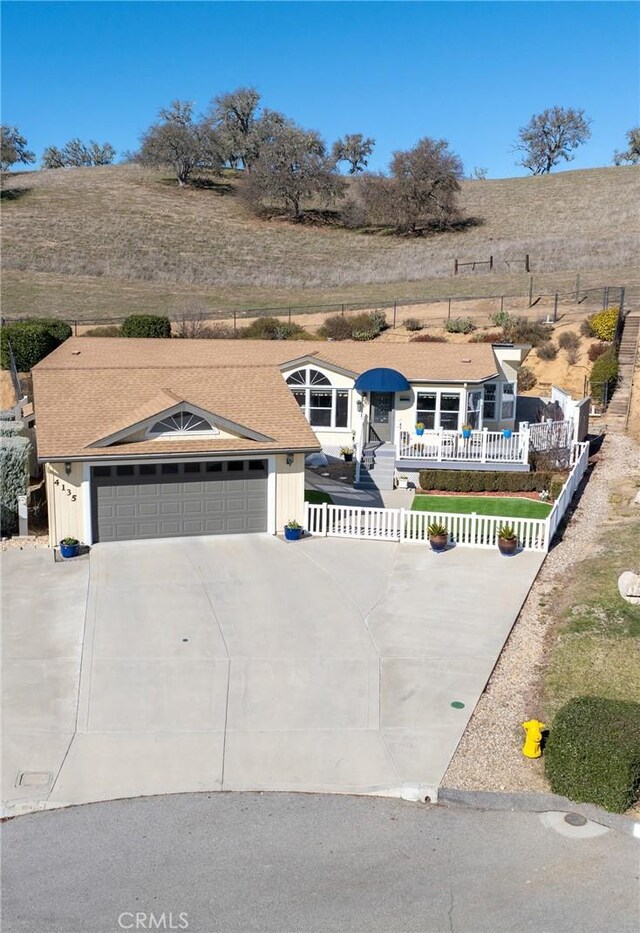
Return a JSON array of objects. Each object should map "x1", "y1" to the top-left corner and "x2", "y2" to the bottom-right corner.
[{"x1": 544, "y1": 696, "x2": 640, "y2": 813}]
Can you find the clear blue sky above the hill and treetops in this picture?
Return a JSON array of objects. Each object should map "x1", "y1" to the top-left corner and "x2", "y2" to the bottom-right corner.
[{"x1": 2, "y1": 0, "x2": 640, "y2": 178}]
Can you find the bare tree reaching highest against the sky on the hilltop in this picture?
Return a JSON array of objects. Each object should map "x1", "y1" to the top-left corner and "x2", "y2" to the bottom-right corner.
[{"x1": 209, "y1": 87, "x2": 260, "y2": 170}]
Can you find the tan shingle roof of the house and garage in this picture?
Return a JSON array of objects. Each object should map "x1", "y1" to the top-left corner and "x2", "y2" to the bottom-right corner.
[{"x1": 33, "y1": 337, "x2": 498, "y2": 460}]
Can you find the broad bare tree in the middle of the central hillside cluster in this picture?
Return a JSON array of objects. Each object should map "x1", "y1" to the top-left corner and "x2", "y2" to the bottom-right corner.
[{"x1": 244, "y1": 114, "x2": 345, "y2": 220}]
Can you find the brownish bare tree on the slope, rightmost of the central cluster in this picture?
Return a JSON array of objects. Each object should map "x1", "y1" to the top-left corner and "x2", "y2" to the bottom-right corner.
[{"x1": 357, "y1": 136, "x2": 463, "y2": 233}]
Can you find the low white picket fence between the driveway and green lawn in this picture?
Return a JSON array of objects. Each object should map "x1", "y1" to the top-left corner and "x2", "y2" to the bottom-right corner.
[{"x1": 305, "y1": 444, "x2": 589, "y2": 552}]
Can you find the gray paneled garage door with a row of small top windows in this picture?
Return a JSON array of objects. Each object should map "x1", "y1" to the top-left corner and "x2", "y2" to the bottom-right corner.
[{"x1": 91, "y1": 460, "x2": 267, "y2": 541}]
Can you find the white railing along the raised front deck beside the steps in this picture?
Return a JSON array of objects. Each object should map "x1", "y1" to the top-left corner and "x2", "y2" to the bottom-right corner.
[{"x1": 398, "y1": 428, "x2": 529, "y2": 464}]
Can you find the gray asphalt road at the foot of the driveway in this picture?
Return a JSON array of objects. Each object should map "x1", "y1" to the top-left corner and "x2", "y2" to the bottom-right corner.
[{"x1": 2, "y1": 793, "x2": 638, "y2": 933}]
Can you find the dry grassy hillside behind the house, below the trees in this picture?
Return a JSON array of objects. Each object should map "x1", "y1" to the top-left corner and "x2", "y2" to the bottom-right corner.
[{"x1": 2, "y1": 165, "x2": 640, "y2": 319}]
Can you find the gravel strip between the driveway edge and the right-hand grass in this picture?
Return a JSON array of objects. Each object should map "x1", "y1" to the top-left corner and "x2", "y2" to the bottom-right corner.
[{"x1": 442, "y1": 433, "x2": 640, "y2": 791}]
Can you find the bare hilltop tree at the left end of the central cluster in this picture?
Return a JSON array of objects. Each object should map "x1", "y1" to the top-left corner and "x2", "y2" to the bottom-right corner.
[{"x1": 137, "y1": 100, "x2": 220, "y2": 187}]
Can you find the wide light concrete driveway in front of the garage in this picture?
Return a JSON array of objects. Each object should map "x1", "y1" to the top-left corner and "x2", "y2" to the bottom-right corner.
[{"x1": 2, "y1": 535, "x2": 542, "y2": 813}]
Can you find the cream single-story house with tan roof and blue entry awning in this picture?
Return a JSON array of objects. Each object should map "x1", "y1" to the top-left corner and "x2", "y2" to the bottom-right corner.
[{"x1": 33, "y1": 337, "x2": 529, "y2": 544}]
